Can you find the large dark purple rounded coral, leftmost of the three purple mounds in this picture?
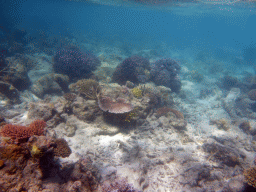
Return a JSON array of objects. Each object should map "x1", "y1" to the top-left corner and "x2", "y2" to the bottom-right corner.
[{"x1": 53, "y1": 47, "x2": 101, "y2": 78}]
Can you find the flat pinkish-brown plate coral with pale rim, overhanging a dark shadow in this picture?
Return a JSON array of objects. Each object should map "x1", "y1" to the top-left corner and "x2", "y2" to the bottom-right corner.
[{"x1": 98, "y1": 96, "x2": 133, "y2": 114}]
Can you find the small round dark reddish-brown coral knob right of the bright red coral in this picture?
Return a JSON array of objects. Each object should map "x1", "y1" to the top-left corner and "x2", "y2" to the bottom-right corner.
[{"x1": 54, "y1": 139, "x2": 71, "y2": 158}]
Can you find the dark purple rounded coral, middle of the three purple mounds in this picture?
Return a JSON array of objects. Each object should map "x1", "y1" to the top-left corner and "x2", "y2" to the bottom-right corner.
[{"x1": 112, "y1": 55, "x2": 150, "y2": 85}]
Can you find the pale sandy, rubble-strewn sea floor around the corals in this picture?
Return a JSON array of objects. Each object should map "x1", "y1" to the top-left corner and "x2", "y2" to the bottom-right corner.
[{"x1": 0, "y1": 48, "x2": 256, "y2": 192}]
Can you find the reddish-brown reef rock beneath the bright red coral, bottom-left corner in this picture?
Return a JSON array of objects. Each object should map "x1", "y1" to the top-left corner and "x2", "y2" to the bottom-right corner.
[{"x1": 0, "y1": 136, "x2": 73, "y2": 191}]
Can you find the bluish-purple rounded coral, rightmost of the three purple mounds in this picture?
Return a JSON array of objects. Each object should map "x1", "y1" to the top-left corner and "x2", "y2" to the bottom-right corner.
[{"x1": 150, "y1": 58, "x2": 181, "y2": 92}]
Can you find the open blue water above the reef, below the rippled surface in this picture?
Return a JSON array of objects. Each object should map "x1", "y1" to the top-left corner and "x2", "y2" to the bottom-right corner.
[{"x1": 1, "y1": 0, "x2": 256, "y2": 65}]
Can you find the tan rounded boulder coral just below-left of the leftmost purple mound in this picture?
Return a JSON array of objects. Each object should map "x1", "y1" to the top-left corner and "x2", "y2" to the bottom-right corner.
[{"x1": 31, "y1": 73, "x2": 69, "y2": 98}]
